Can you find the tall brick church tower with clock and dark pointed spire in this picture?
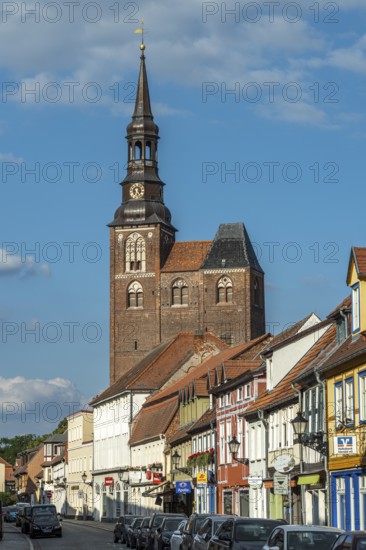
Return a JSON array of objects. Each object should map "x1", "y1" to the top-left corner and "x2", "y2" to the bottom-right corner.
[{"x1": 108, "y1": 43, "x2": 176, "y2": 383}]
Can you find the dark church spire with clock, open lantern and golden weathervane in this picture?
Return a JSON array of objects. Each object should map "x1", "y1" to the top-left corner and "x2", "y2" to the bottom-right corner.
[{"x1": 109, "y1": 41, "x2": 174, "y2": 229}]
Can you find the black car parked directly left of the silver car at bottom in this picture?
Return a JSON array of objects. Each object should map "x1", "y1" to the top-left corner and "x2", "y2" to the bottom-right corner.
[{"x1": 208, "y1": 517, "x2": 284, "y2": 550}]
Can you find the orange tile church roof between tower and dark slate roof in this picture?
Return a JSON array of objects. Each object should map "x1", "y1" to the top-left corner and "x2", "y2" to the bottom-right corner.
[{"x1": 161, "y1": 241, "x2": 212, "y2": 273}]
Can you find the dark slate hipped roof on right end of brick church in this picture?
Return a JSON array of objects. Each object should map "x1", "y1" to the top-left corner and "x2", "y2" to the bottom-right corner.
[{"x1": 201, "y1": 223, "x2": 263, "y2": 273}]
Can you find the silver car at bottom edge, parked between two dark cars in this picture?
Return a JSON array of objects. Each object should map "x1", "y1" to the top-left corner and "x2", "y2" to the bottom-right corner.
[{"x1": 263, "y1": 525, "x2": 344, "y2": 550}]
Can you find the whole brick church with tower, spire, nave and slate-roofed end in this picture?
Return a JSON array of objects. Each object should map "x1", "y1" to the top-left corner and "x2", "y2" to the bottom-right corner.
[{"x1": 109, "y1": 45, "x2": 265, "y2": 384}]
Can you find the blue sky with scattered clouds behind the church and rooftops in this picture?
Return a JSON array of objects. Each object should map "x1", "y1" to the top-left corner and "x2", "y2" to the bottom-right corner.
[{"x1": 0, "y1": 0, "x2": 366, "y2": 440}]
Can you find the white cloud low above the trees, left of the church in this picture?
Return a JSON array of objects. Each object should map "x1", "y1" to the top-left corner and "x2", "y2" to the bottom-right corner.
[{"x1": 0, "y1": 376, "x2": 87, "y2": 435}]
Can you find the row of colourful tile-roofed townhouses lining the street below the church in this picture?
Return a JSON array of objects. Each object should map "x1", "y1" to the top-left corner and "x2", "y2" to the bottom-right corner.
[{"x1": 11, "y1": 248, "x2": 366, "y2": 529}]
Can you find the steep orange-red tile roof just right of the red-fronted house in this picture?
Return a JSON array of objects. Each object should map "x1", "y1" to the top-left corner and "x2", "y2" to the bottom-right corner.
[{"x1": 244, "y1": 324, "x2": 336, "y2": 416}]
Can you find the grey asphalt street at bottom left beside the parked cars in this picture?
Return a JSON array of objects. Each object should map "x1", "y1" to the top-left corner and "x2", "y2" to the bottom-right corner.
[{"x1": 0, "y1": 521, "x2": 118, "y2": 550}]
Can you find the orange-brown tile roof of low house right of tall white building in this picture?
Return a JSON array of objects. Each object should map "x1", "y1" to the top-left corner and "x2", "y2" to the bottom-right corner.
[{"x1": 130, "y1": 397, "x2": 178, "y2": 445}]
